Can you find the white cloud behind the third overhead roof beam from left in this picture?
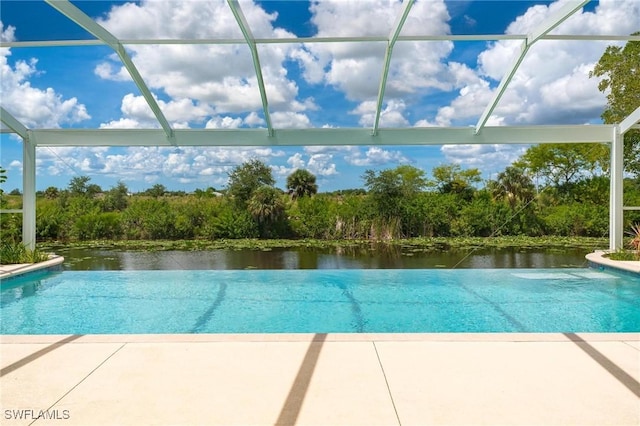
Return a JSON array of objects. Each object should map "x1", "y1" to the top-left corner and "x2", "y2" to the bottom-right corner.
[{"x1": 291, "y1": 0, "x2": 453, "y2": 127}]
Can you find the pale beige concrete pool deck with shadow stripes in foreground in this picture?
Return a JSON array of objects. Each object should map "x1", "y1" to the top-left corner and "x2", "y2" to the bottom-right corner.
[{"x1": 0, "y1": 333, "x2": 640, "y2": 425}]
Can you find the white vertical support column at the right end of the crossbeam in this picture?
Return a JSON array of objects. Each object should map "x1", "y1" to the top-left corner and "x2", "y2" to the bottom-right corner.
[{"x1": 609, "y1": 126, "x2": 624, "y2": 251}]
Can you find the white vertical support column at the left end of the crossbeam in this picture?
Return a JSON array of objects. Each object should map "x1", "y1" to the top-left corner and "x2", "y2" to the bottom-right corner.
[{"x1": 22, "y1": 137, "x2": 36, "y2": 250}]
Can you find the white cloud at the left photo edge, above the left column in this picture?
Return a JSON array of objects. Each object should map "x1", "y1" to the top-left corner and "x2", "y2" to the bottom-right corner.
[{"x1": 0, "y1": 21, "x2": 91, "y2": 128}]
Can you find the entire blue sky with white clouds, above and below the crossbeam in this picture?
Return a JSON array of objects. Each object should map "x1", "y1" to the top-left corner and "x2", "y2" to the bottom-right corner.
[{"x1": 0, "y1": 0, "x2": 640, "y2": 191}]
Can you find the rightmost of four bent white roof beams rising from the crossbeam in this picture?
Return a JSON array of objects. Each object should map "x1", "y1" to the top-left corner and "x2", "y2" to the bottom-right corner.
[{"x1": 475, "y1": 0, "x2": 590, "y2": 133}]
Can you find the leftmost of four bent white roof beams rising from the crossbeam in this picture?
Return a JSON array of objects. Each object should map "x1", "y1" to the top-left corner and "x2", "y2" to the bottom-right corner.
[{"x1": 45, "y1": 0, "x2": 174, "y2": 142}]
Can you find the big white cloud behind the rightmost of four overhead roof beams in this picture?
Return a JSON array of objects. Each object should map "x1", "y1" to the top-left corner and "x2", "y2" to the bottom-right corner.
[{"x1": 432, "y1": 0, "x2": 640, "y2": 125}]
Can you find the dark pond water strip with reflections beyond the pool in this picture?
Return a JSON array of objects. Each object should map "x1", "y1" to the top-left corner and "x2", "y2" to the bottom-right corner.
[{"x1": 56, "y1": 246, "x2": 589, "y2": 271}]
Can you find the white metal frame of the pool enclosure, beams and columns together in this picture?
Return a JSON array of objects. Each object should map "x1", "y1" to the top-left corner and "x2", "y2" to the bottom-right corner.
[{"x1": 0, "y1": 0, "x2": 640, "y2": 250}]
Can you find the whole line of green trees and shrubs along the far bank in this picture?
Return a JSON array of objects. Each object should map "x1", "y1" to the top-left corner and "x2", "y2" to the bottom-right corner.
[{"x1": 1, "y1": 144, "x2": 640, "y2": 241}]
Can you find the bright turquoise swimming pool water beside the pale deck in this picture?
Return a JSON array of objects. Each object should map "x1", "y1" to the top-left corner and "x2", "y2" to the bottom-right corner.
[{"x1": 0, "y1": 269, "x2": 640, "y2": 334}]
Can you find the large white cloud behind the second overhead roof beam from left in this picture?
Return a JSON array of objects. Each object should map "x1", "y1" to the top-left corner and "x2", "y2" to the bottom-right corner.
[{"x1": 95, "y1": 1, "x2": 314, "y2": 127}]
